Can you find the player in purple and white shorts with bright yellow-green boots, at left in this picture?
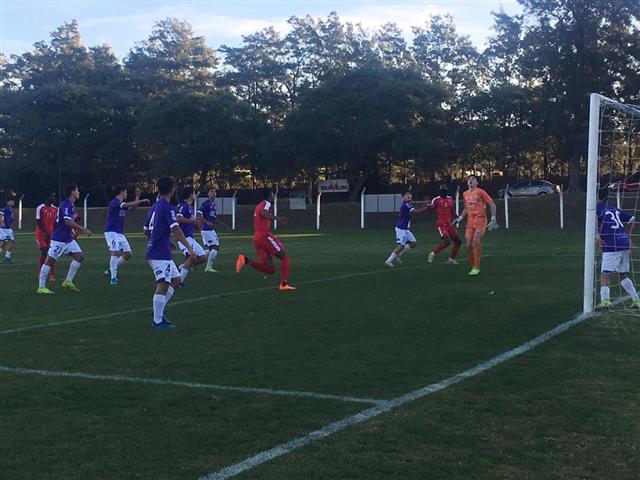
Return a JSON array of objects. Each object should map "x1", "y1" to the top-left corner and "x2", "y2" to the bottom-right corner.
[{"x1": 38, "y1": 184, "x2": 91, "y2": 294}]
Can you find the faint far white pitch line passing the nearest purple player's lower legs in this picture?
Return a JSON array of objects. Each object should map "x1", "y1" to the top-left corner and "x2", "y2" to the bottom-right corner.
[{"x1": 0, "y1": 265, "x2": 422, "y2": 335}]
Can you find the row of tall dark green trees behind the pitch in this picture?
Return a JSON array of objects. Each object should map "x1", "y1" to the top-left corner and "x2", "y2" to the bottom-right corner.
[{"x1": 0, "y1": 0, "x2": 640, "y2": 203}]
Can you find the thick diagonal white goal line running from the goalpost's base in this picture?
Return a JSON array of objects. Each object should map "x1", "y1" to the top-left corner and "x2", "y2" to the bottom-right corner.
[{"x1": 200, "y1": 313, "x2": 598, "y2": 480}]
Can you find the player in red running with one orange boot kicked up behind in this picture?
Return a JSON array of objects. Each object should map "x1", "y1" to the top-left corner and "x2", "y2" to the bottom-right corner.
[{"x1": 236, "y1": 188, "x2": 296, "y2": 291}]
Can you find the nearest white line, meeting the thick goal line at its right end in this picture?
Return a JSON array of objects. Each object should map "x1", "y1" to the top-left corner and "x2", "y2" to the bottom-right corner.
[{"x1": 0, "y1": 366, "x2": 387, "y2": 405}]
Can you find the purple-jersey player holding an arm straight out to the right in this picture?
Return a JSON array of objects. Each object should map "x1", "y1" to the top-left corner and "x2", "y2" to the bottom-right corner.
[{"x1": 104, "y1": 185, "x2": 149, "y2": 285}]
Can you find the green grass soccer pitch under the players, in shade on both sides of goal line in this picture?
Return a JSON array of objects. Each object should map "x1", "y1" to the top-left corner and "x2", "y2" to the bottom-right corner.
[{"x1": 0, "y1": 231, "x2": 640, "y2": 480}]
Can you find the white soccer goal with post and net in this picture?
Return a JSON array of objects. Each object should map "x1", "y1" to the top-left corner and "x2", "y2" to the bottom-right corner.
[{"x1": 583, "y1": 93, "x2": 640, "y2": 314}]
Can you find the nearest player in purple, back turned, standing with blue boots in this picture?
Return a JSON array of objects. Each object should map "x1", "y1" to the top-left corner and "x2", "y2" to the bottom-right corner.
[{"x1": 146, "y1": 177, "x2": 195, "y2": 330}]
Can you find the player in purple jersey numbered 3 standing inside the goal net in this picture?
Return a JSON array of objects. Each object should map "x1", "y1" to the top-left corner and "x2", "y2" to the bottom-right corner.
[{"x1": 596, "y1": 188, "x2": 640, "y2": 309}]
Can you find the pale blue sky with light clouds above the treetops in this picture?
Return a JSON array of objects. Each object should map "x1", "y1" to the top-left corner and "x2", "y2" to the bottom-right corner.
[{"x1": 0, "y1": 0, "x2": 521, "y2": 58}]
